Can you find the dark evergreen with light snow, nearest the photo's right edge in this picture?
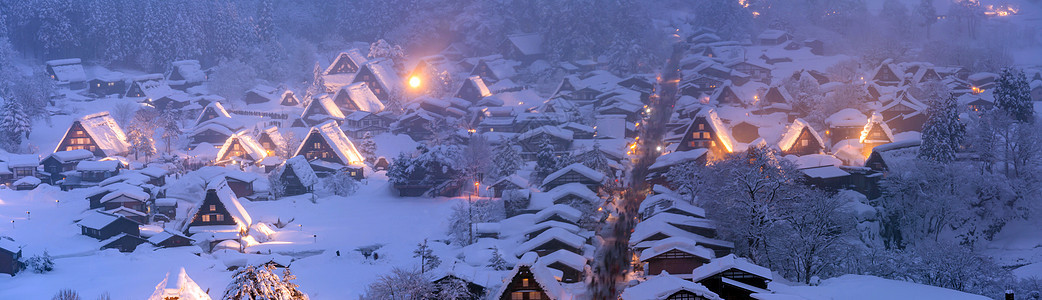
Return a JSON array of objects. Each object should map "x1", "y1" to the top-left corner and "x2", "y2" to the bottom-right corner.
[{"x1": 994, "y1": 68, "x2": 1035, "y2": 122}]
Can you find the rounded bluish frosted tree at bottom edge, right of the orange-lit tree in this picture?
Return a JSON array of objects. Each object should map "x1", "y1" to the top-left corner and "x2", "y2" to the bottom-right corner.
[{"x1": 361, "y1": 267, "x2": 435, "y2": 300}]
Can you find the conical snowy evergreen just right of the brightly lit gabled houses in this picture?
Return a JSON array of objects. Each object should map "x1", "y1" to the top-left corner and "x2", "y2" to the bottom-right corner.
[{"x1": 919, "y1": 94, "x2": 966, "y2": 163}]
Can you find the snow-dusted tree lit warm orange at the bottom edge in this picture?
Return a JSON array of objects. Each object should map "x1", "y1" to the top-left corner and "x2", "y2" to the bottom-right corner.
[{"x1": 222, "y1": 264, "x2": 307, "y2": 300}]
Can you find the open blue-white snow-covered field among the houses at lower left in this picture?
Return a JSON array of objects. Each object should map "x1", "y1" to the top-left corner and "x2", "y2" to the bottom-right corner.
[{"x1": 0, "y1": 178, "x2": 460, "y2": 299}]
